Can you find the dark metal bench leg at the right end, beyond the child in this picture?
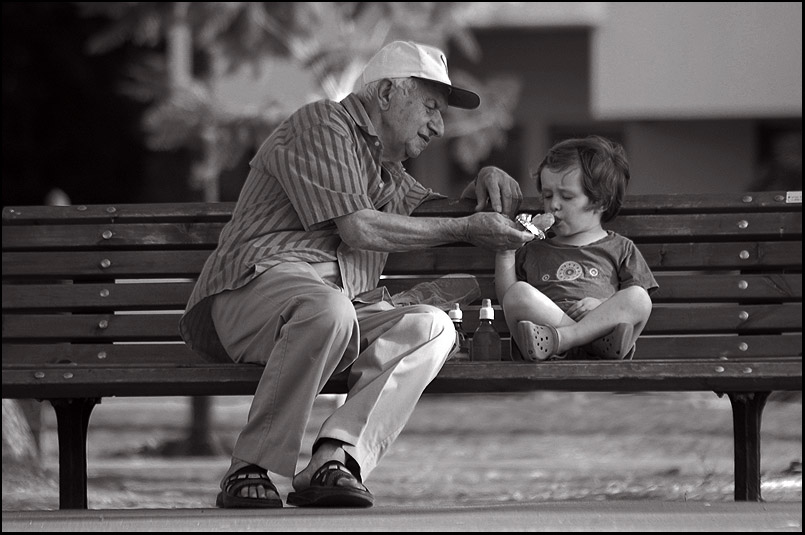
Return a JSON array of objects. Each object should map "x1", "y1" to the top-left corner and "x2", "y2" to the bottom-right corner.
[{"x1": 728, "y1": 392, "x2": 771, "y2": 502}]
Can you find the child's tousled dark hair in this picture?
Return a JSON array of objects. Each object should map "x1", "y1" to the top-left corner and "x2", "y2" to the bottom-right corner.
[{"x1": 531, "y1": 136, "x2": 630, "y2": 223}]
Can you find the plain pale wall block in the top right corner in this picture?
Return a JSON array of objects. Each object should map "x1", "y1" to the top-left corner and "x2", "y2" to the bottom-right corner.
[{"x1": 591, "y1": 2, "x2": 802, "y2": 120}]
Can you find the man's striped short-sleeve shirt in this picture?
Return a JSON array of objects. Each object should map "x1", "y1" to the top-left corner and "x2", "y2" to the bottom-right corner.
[{"x1": 179, "y1": 94, "x2": 439, "y2": 361}]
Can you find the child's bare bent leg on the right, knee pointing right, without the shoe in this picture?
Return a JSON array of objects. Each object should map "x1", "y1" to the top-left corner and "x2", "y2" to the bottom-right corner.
[{"x1": 552, "y1": 286, "x2": 651, "y2": 351}]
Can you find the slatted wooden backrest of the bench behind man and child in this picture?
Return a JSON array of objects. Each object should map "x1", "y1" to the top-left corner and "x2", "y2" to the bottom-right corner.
[{"x1": 3, "y1": 192, "x2": 802, "y2": 396}]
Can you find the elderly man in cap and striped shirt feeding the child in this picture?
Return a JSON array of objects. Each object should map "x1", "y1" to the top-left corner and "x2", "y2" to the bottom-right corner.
[{"x1": 180, "y1": 41, "x2": 533, "y2": 507}]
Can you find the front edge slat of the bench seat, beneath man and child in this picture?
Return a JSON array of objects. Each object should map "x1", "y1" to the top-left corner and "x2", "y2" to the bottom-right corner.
[{"x1": 3, "y1": 358, "x2": 802, "y2": 399}]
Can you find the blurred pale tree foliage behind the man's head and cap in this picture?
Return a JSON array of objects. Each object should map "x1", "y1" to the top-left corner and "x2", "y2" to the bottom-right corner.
[{"x1": 76, "y1": 2, "x2": 519, "y2": 201}]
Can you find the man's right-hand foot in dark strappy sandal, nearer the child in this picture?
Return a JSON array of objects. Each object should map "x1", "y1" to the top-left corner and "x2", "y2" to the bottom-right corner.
[{"x1": 288, "y1": 461, "x2": 374, "y2": 507}]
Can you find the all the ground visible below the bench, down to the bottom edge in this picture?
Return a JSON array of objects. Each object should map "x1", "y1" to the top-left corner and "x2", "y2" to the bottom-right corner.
[{"x1": 3, "y1": 392, "x2": 802, "y2": 531}]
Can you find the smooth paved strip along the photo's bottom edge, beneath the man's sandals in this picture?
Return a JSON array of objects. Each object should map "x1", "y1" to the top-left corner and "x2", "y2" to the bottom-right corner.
[{"x1": 3, "y1": 501, "x2": 802, "y2": 533}]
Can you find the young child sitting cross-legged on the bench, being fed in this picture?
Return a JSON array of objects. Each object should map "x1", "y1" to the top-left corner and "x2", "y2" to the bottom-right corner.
[{"x1": 495, "y1": 136, "x2": 658, "y2": 361}]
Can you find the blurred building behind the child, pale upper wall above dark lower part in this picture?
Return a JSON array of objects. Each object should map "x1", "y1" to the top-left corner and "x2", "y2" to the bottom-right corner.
[{"x1": 417, "y1": 2, "x2": 802, "y2": 198}]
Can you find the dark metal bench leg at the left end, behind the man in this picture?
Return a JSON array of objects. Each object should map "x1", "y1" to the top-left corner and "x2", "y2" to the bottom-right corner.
[{"x1": 50, "y1": 398, "x2": 100, "y2": 509}]
